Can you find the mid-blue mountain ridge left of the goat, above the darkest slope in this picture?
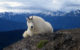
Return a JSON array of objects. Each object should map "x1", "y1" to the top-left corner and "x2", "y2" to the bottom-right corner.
[{"x1": 0, "y1": 18, "x2": 27, "y2": 32}]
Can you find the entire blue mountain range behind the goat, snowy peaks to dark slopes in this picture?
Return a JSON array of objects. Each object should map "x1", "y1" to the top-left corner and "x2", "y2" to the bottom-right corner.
[{"x1": 0, "y1": 10, "x2": 80, "y2": 49}]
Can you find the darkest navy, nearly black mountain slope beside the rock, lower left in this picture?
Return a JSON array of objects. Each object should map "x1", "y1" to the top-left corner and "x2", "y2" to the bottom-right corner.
[{"x1": 0, "y1": 30, "x2": 25, "y2": 50}]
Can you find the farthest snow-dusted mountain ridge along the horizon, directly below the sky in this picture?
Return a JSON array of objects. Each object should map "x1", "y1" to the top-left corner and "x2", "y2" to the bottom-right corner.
[{"x1": 0, "y1": 10, "x2": 80, "y2": 23}]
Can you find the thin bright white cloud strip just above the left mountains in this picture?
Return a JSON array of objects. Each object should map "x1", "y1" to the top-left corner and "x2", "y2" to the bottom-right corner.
[{"x1": 0, "y1": 9, "x2": 42, "y2": 13}]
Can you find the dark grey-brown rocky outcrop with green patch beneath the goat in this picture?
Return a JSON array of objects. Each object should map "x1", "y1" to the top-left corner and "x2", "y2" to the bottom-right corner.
[{"x1": 3, "y1": 29, "x2": 80, "y2": 50}]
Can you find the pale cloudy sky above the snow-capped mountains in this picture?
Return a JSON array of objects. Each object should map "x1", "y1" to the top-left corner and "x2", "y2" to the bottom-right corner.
[{"x1": 0, "y1": 0, "x2": 80, "y2": 12}]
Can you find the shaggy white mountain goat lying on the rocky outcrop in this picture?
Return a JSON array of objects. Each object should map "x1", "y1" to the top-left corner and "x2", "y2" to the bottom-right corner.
[{"x1": 23, "y1": 16, "x2": 53, "y2": 38}]
